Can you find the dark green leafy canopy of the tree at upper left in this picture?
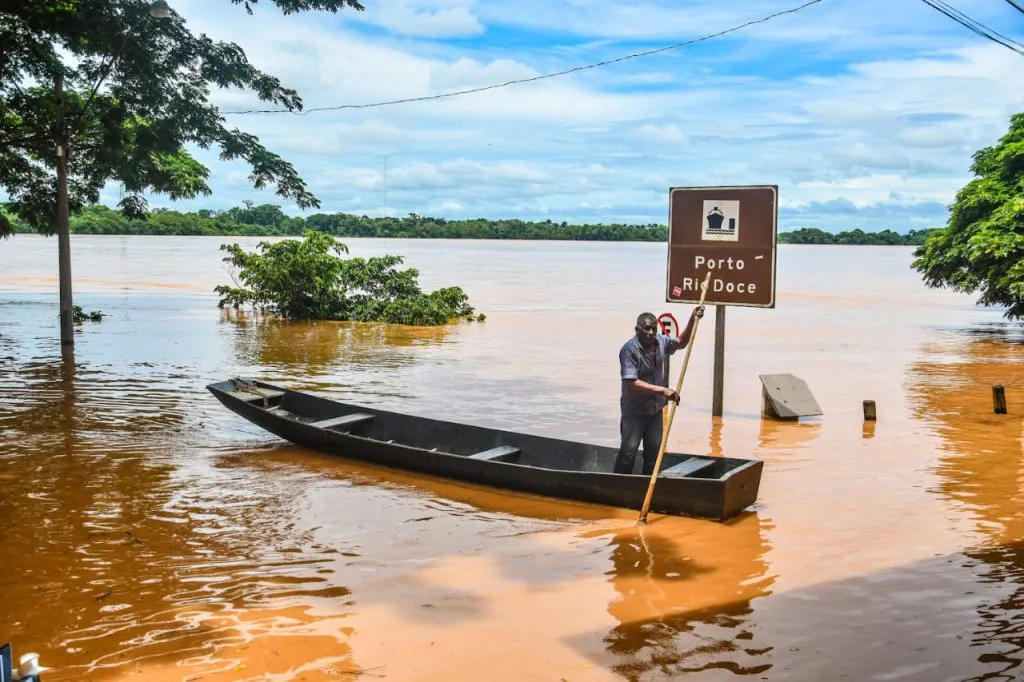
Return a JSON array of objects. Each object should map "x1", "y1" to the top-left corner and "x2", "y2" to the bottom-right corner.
[{"x1": 0, "y1": 0, "x2": 362, "y2": 237}]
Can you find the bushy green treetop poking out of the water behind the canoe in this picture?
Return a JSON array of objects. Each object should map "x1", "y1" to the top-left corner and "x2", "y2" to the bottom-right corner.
[{"x1": 214, "y1": 231, "x2": 483, "y2": 326}]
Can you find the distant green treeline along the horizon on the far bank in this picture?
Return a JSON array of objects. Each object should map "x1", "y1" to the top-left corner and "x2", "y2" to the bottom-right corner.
[{"x1": 0, "y1": 203, "x2": 933, "y2": 246}]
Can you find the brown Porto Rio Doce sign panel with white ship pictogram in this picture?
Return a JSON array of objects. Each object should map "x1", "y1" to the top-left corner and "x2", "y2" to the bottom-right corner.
[{"x1": 666, "y1": 184, "x2": 778, "y2": 308}]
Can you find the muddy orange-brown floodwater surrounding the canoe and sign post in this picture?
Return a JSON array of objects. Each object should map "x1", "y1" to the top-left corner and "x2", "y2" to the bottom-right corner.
[{"x1": 0, "y1": 236, "x2": 1024, "y2": 682}]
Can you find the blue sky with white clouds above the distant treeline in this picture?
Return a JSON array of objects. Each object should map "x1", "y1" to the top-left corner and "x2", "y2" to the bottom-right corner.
[{"x1": 114, "y1": 0, "x2": 1024, "y2": 232}]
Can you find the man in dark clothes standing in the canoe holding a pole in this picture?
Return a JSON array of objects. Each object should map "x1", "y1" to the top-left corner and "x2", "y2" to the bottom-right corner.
[{"x1": 614, "y1": 305, "x2": 703, "y2": 476}]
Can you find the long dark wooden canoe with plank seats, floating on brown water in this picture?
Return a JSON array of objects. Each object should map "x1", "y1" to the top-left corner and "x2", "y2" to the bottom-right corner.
[{"x1": 207, "y1": 380, "x2": 763, "y2": 520}]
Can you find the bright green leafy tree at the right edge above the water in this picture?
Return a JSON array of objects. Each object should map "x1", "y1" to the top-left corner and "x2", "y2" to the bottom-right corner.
[{"x1": 911, "y1": 113, "x2": 1024, "y2": 319}]
